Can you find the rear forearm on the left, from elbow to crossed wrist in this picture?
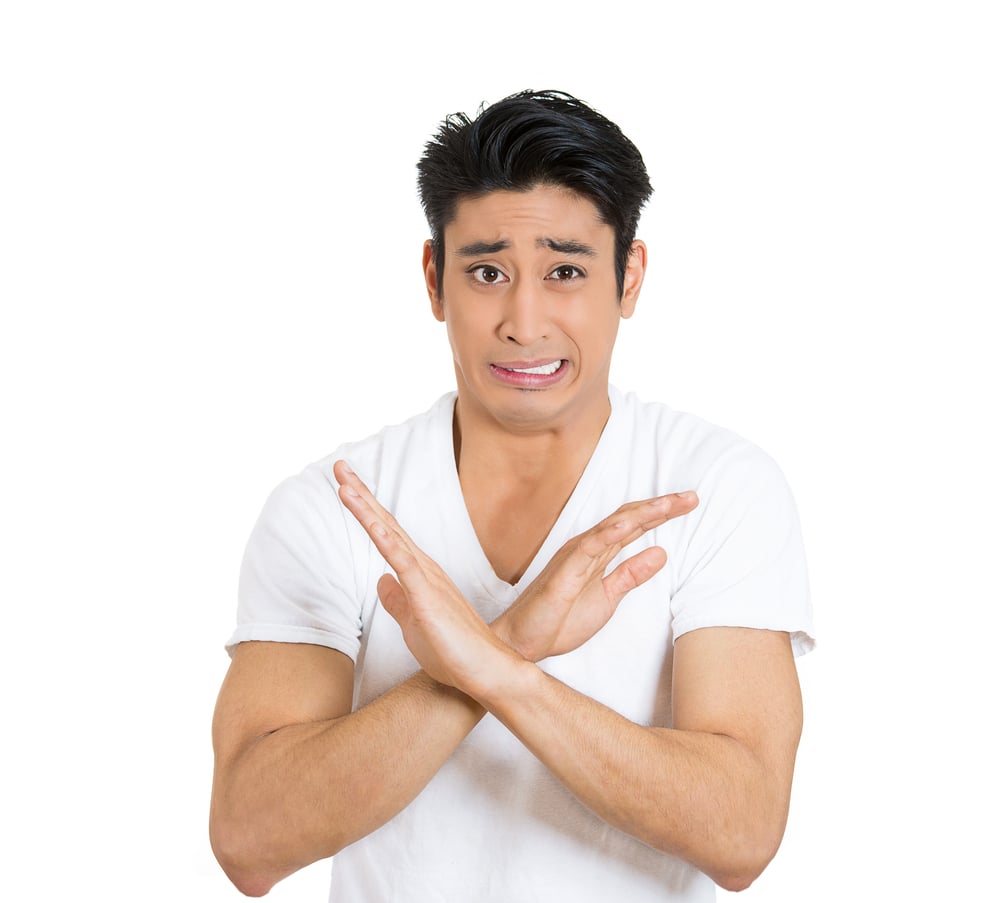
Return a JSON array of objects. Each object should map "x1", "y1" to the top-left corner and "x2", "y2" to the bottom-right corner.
[{"x1": 212, "y1": 672, "x2": 484, "y2": 895}]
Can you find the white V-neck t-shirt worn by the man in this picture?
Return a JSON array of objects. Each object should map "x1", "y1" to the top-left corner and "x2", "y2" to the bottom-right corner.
[{"x1": 229, "y1": 388, "x2": 813, "y2": 903}]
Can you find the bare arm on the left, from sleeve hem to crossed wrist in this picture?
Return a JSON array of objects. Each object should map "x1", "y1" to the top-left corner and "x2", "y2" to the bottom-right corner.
[{"x1": 209, "y1": 643, "x2": 483, "y2": 896}]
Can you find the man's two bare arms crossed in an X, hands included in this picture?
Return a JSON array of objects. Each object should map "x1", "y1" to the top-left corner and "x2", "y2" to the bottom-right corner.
[{"x1": 211, "y1": 462, "x2": 801, "y2": 896}]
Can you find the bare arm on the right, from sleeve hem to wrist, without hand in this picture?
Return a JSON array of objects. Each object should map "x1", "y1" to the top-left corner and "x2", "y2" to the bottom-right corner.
[{"x1": 476, "y1": 628, "x2": 802, "y2": 890}]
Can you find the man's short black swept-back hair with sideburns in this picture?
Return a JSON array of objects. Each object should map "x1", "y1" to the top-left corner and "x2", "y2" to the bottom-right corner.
[{"x1": 417, "y1": 90, "x2": 653, "y2": 297}]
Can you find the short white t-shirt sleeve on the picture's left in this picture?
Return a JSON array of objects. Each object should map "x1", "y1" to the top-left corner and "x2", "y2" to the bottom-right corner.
[{"x1": 226, "y1": 465, "x2": 364, "y2": 660}]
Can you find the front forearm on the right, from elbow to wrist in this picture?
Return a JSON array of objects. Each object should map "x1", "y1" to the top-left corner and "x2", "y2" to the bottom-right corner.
[{"x1": 479, "y1": 663, "x2": 788, "y2": 889}]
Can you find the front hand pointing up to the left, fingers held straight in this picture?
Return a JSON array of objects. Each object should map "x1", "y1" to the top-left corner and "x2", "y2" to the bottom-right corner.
[{"x1": 333, "y1": 461, "x2": 520, "y2": 698}]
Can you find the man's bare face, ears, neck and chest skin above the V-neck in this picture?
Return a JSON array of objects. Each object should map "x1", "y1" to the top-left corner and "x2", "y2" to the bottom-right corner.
[{"x1": 424, "y1": 186, "x2": 646, "y2": 583}]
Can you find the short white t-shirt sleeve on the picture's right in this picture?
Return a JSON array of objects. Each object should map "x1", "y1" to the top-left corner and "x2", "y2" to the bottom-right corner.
[{"x1": 671, "y1": 441, "x2": 815, "y2": 655}]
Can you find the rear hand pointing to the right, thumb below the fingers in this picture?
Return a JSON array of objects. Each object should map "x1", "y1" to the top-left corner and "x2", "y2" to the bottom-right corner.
[{"x1": 491, "y1": 492, "x2": 698, "y2": 662}]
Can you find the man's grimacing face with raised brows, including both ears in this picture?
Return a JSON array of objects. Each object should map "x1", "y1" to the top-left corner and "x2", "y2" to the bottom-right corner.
[{"x1": 424, "y1": 186, "x2": 646, "y2": 432}]
